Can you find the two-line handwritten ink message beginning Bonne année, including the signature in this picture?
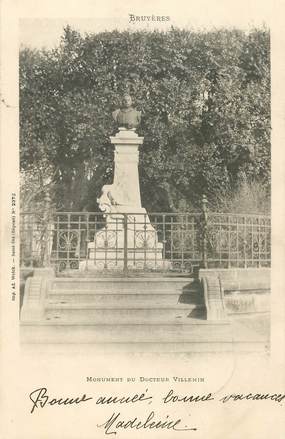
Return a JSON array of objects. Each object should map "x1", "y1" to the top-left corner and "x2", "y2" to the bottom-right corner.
[{"x1": 29, "y1": 387, "x2": 285, "y2": 435}]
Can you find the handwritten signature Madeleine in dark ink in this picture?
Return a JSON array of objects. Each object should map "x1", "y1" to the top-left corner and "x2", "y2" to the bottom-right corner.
[{"x1": 97, "y1": 411, "x2": 197, "y2": 435}]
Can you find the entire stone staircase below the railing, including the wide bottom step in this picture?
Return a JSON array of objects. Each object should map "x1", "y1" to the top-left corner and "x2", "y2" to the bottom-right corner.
[{"x1": 21, "y1": 277, "x2": 268, "y2": 353}]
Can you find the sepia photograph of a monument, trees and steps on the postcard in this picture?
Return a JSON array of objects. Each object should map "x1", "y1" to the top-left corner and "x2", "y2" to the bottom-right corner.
[{"x1": 19, "y1": 14, "x2": 271, "y2": 353}]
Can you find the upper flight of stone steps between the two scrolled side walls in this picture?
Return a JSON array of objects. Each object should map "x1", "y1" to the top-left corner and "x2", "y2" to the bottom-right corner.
[{"x1": 45, "y1": 278, "x2": 204, "y2": 316}]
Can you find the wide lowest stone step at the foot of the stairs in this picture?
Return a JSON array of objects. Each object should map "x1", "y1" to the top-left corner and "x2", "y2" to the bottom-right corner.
[{"x1": 21, "y1": 321, "x2": 232, "y2": 345}]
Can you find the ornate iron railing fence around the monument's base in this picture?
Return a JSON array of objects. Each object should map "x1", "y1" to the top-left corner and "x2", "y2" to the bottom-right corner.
[{"x1": 20, "y1": 209, "x2": 271, "y2": 273}]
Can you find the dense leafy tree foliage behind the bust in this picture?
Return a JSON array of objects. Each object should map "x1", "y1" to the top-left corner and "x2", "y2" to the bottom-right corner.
[{"x1": 20, "y1": 27, "x2": 270, "y2": 211}]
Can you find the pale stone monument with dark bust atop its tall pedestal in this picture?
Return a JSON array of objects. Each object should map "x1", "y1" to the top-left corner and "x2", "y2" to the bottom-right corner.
[{"x1": 80, "y1": 95, "x2": 165, "y2": 270}]
